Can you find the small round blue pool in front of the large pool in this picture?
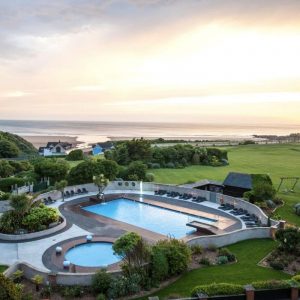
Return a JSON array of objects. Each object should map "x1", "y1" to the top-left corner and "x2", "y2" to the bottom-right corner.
[{"x1": 65, "y1": 242, "x2": 120, "y2": 267}]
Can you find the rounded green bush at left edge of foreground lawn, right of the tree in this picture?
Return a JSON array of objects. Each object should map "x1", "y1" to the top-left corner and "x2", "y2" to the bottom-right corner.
[{"x1": 155, "y1": 239, "x2": 191, "y2": 276}]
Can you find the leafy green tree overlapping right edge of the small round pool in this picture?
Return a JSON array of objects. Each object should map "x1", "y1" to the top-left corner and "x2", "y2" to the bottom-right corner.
[{"x1": 113, "y1": 232, "x2": 150, "y2": 274}]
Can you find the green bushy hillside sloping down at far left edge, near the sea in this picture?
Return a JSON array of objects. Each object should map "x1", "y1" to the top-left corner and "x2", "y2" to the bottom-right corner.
[{"x1": 0, "y1": 131, "x2": 37, "y2": 157}]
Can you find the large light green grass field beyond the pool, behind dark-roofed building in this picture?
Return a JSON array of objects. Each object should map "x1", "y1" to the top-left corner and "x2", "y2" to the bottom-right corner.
[{"x1": 150, "y1": 144, "x2": 300, "y2": 226}]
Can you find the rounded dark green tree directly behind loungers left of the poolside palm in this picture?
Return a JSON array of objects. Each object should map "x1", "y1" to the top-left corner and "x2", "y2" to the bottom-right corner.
[{"x1": 68, "y1": 161, "x2": 94, "y2": 184}]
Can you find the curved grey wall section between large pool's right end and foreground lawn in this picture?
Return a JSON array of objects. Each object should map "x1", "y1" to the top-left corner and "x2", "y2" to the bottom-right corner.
[{"x1": 187, "y1": 227, "x2": 271, "y2": 248}]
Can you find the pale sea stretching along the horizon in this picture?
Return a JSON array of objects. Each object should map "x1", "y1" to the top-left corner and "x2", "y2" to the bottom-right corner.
[{"x1": 0, "y1": 120, "x2": 300, "y2": 143}]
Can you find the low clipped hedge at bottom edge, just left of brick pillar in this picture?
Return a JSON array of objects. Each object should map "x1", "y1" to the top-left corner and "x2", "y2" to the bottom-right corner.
[{"x1": 191, "y1": 283, "x2": 244, "y2": 297}]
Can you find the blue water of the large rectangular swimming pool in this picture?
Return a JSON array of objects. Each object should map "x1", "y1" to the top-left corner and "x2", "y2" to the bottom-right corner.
[{"x1": 84, "y1": 199, "x2": 217, "y2": 238}]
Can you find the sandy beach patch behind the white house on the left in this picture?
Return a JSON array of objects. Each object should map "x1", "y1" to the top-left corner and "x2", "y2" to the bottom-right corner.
[{"x1": 22, "y1": 135, "x2": 83, "y2": 149}]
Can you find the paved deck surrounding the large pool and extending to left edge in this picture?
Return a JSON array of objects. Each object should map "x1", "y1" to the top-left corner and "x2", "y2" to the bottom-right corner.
[{"x1": 0, "y1": 192, "x2": 243, "y2": 271}]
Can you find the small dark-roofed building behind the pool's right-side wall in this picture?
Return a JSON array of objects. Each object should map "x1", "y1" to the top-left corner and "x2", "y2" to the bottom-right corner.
[{"x1": 223, "y1": 172, "x2": 252, "y2": 197}]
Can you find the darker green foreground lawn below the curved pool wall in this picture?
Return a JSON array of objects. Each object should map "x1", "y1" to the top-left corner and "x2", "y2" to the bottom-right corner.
[{"x1": 145, "y1": 239, "x2": 290, "y2": 299}]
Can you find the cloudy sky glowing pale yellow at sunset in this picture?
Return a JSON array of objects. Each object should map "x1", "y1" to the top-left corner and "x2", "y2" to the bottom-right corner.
[{"x1": 0, "y1": 0, "x2": 300, "y2": 125}]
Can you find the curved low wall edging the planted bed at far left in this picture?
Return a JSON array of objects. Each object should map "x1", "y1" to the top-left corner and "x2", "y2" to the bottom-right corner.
[{"x1": 0, "y1": 216, "x2": 67, "y2": 242}]
